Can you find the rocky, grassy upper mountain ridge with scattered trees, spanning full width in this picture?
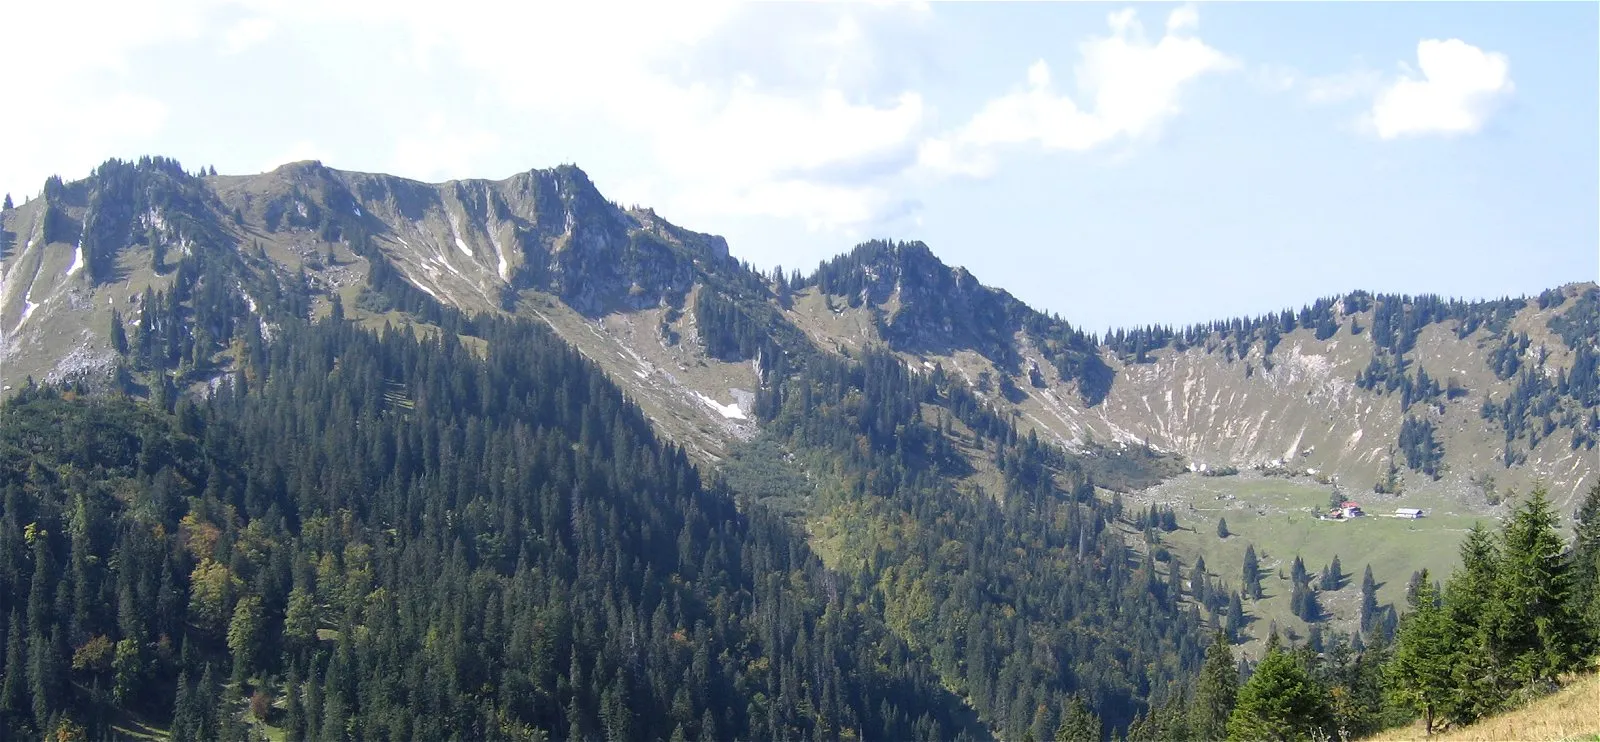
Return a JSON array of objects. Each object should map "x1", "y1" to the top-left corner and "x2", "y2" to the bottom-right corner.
[{"x1": 0, "y1": 158, "x2": 1600, "y2": 510}]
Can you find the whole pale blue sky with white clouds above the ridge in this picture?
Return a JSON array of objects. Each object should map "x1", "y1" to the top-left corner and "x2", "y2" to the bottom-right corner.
[{"x1": 0, "y1": 0, "x2": 1600, "y2": 331}]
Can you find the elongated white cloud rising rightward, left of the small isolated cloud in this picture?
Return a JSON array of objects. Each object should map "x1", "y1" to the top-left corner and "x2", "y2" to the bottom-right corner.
[{"x1": 920, "y1": 5, "x2": 1238, "y2": 174}]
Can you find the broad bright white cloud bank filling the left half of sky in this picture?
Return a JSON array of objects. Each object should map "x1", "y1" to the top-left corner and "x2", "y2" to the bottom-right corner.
[{"x1": 0, "y1": 0, "x2": 931, "y2": 229}]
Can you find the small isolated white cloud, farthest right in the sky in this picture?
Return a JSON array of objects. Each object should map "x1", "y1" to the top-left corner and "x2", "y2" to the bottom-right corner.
[{"x1": 1365, "y1": 38, "x2": 1514, "y2": 139}]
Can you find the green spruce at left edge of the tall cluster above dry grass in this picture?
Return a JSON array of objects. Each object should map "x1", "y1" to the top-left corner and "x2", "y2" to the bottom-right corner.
[{"x1": 1384, "y1": 569, "x2": 1458, "y2": 734}]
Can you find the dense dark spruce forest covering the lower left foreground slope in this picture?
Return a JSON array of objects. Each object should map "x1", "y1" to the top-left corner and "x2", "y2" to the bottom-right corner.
[{"x1": 0, "y1": 311, "x2": 965, "y2": 739}]
